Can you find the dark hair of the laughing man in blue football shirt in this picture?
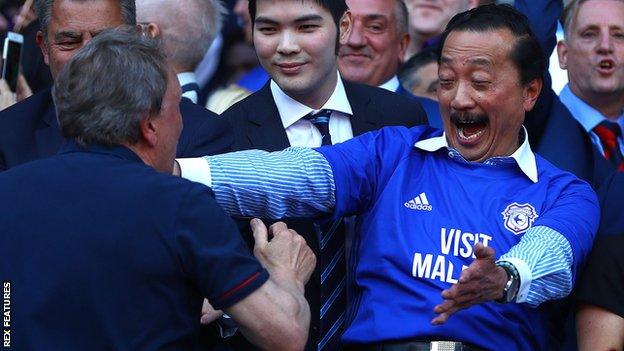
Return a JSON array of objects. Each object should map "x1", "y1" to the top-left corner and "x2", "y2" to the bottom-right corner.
[{"x1": 438, "y1": 4, "x2": 546, "y2": 85}]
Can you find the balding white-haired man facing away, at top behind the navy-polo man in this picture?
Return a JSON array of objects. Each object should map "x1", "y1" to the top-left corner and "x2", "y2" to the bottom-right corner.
[{"x1": 136, "y1": 0, "x2": 226, "y2": 103}]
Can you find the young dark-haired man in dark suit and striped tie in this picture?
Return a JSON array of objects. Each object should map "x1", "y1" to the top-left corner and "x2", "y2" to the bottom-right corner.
[{"x1": 217, "y1": 0, "x2": 427, "y2": 350}]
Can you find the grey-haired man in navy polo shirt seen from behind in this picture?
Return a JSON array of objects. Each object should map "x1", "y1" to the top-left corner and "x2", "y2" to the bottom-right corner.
[{"x1": 0, "y1": 30, "x2": 315, "y2": 350}]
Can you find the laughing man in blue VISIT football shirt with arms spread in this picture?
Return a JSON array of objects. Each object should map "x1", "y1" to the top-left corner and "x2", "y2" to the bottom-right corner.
[{"x1": 179, "y1": 5, "x2": 599, "y2": 350}]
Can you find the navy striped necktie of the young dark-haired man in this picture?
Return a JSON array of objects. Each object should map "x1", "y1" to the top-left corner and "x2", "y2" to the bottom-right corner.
[{"x1": 305, "y1": 110, "x2": 347, "y2": 351}]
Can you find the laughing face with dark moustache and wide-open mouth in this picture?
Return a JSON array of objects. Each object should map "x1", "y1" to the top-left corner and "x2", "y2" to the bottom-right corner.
[{"x1": 438, "y1": 29, "x2": 541, "y2": 162}]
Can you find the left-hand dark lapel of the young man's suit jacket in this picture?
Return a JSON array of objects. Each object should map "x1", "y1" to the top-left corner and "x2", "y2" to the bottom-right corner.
[{"x1": 245, "y1": 83, "x2": 290, "y2": 151}]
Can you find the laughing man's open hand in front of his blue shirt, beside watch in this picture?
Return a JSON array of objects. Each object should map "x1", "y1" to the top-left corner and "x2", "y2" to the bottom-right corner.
[{"x1": 431, "y1": 243, "x2": 507, "y2": 325}]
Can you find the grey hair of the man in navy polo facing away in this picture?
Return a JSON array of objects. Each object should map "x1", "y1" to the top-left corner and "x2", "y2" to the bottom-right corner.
[{"x1": 53, "y1": 27, "x2": 168, "y2": 146}]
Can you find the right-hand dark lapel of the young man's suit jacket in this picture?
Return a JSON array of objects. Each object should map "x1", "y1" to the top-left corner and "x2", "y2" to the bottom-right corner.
[{"x1": 343, "y1": 80, "x2": 381, "y2": 136}]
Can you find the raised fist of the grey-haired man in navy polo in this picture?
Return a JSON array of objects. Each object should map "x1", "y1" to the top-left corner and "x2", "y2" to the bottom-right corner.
[{"x1": 251, "y1": 218, "x2": 316, "y2": 291}]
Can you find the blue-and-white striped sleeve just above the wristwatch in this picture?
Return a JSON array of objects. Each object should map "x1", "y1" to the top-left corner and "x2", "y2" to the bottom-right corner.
[{"x1": 499, "y1": 226, "x2": 574, "y2": 307}]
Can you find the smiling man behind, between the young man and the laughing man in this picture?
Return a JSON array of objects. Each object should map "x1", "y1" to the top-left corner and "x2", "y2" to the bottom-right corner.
[{"x1": 338, "y1": 0, "x2": 442, "y2": 127}]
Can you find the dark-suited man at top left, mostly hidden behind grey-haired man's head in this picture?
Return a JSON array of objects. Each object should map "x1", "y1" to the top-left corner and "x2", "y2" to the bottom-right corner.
[{"x1": 0, "y1": 0, "x2": 231, "y2": 171}]
